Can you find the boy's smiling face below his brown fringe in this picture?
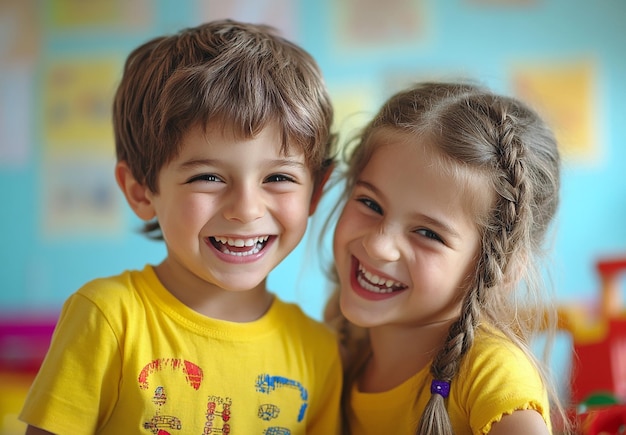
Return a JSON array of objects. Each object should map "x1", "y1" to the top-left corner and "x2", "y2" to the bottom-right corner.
[{"x1": 146, "y1": 124, "x2": 314, "y2": 293}]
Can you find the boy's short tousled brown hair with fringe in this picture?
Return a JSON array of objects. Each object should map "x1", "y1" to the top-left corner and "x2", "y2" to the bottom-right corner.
[{"x1": 113, "y1": 20, "x2": 335, "y2": 238}]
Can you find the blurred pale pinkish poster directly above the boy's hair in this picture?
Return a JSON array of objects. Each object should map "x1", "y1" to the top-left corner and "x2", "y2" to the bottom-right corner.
[{"x1": 197, "y1": 0, "x2": 299, "y2": 40}]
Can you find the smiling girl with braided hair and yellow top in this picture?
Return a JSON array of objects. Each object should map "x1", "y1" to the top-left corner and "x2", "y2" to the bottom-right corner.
[{"x1": 326, "y1": 83, "x2": 560, "y2": 435}]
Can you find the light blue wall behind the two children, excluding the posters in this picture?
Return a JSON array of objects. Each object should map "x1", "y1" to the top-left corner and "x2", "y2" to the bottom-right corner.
[{"x1": 0, "y1": 0, "x2": 626, "y2": 340}]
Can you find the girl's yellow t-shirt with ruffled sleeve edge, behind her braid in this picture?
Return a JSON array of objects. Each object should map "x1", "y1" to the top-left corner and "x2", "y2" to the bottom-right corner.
[{"x1": 348, "y1": 328, "x2": 550, "y2": 435}]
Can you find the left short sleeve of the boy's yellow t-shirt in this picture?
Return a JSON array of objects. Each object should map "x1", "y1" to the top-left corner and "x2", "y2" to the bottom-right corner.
[{"x1": 21, "y1": 294, "x2": 122, "y2": 435}]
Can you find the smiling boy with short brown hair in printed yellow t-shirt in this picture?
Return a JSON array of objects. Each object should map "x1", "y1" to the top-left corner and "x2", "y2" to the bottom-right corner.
[{"x1": 21, "y1": 20, "x2": 341, "y2": 435}]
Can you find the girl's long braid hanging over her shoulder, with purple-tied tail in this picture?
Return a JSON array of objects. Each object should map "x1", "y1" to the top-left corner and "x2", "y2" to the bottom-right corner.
[{"x1": 417, "y1": 97, "x2": 529, "y2": 435}]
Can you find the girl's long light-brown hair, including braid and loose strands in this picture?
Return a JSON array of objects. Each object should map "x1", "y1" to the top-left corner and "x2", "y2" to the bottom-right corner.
[{"x1": 327, "y1": 83, "x2": 562, "y2": 434}]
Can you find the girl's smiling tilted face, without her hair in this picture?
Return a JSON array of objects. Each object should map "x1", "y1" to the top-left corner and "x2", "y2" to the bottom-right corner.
[{"x1": 334, "y1": 130, "x2": 480, "y2": 327}]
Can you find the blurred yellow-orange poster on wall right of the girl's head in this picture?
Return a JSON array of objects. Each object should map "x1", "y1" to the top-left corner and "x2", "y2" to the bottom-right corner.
[{"x1": 512, "y1": 60, "x2": 601, "y2": 164}]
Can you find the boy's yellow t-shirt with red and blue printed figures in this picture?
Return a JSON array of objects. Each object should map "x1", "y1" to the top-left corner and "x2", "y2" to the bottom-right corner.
[{"x1": 20, "y1": 266, "x2": 341, "y2": 435}]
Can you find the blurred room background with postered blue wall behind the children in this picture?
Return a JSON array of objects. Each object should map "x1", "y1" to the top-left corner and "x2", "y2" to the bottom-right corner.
[{"x1": 0, "y1": 0, "x2": 626, "y2": 434}]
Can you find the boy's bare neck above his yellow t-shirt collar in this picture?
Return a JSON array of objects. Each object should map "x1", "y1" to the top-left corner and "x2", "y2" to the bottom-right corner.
[{"x1": 154, "y1": 262, "x2": 274, "y2": 323}]
